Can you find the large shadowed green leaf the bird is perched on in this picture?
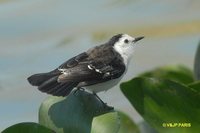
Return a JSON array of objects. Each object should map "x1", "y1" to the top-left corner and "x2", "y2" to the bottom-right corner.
[{"x1": 39, "y1": 90, "x2": 115, "y2": 133}]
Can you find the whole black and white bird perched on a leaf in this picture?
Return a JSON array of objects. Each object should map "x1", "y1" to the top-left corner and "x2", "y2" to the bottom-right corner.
[{"x1": 28, "y1": 34, "x2": 144, "y2": 96}]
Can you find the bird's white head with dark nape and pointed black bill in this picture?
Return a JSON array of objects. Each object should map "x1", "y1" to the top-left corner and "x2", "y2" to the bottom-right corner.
[{"x1": 111, "y1": 34, "x2": 144, "y2": 64}]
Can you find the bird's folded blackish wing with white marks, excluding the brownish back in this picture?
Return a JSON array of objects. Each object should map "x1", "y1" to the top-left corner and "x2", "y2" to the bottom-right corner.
[{"x1": 58, "y1": 50, "x2": 125, "y2": 84}]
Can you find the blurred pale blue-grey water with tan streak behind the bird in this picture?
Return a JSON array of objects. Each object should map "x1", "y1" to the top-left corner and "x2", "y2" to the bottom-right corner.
[{"x1": 0, "y1": 0, "x2": 200, "y2": 131}]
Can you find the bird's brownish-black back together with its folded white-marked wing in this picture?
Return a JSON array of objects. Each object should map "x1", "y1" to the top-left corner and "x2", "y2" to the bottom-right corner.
[{"x1": 58, "y1": 46, "x2": 125, "y2": 84}]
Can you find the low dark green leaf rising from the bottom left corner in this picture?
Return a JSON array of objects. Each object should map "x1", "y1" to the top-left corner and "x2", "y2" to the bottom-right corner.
[{"x1": 2, "y1": 122, "x2": 55, "y2": 133}]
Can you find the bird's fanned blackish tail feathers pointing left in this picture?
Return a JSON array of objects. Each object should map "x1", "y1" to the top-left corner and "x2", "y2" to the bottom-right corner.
[{"x1": 27, "y1": 72, "x2": 78, "y2": 96}]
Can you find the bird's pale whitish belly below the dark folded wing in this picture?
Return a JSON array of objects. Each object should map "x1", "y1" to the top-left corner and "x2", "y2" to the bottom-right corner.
[{"x1": 85, "y1": 76, "x2": 123, "y2": 93}]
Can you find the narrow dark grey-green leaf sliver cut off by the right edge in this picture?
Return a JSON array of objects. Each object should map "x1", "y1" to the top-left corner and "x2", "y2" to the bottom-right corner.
[{"x1": 194, "y1": 42, "x2": 200, "y2": 80}]
